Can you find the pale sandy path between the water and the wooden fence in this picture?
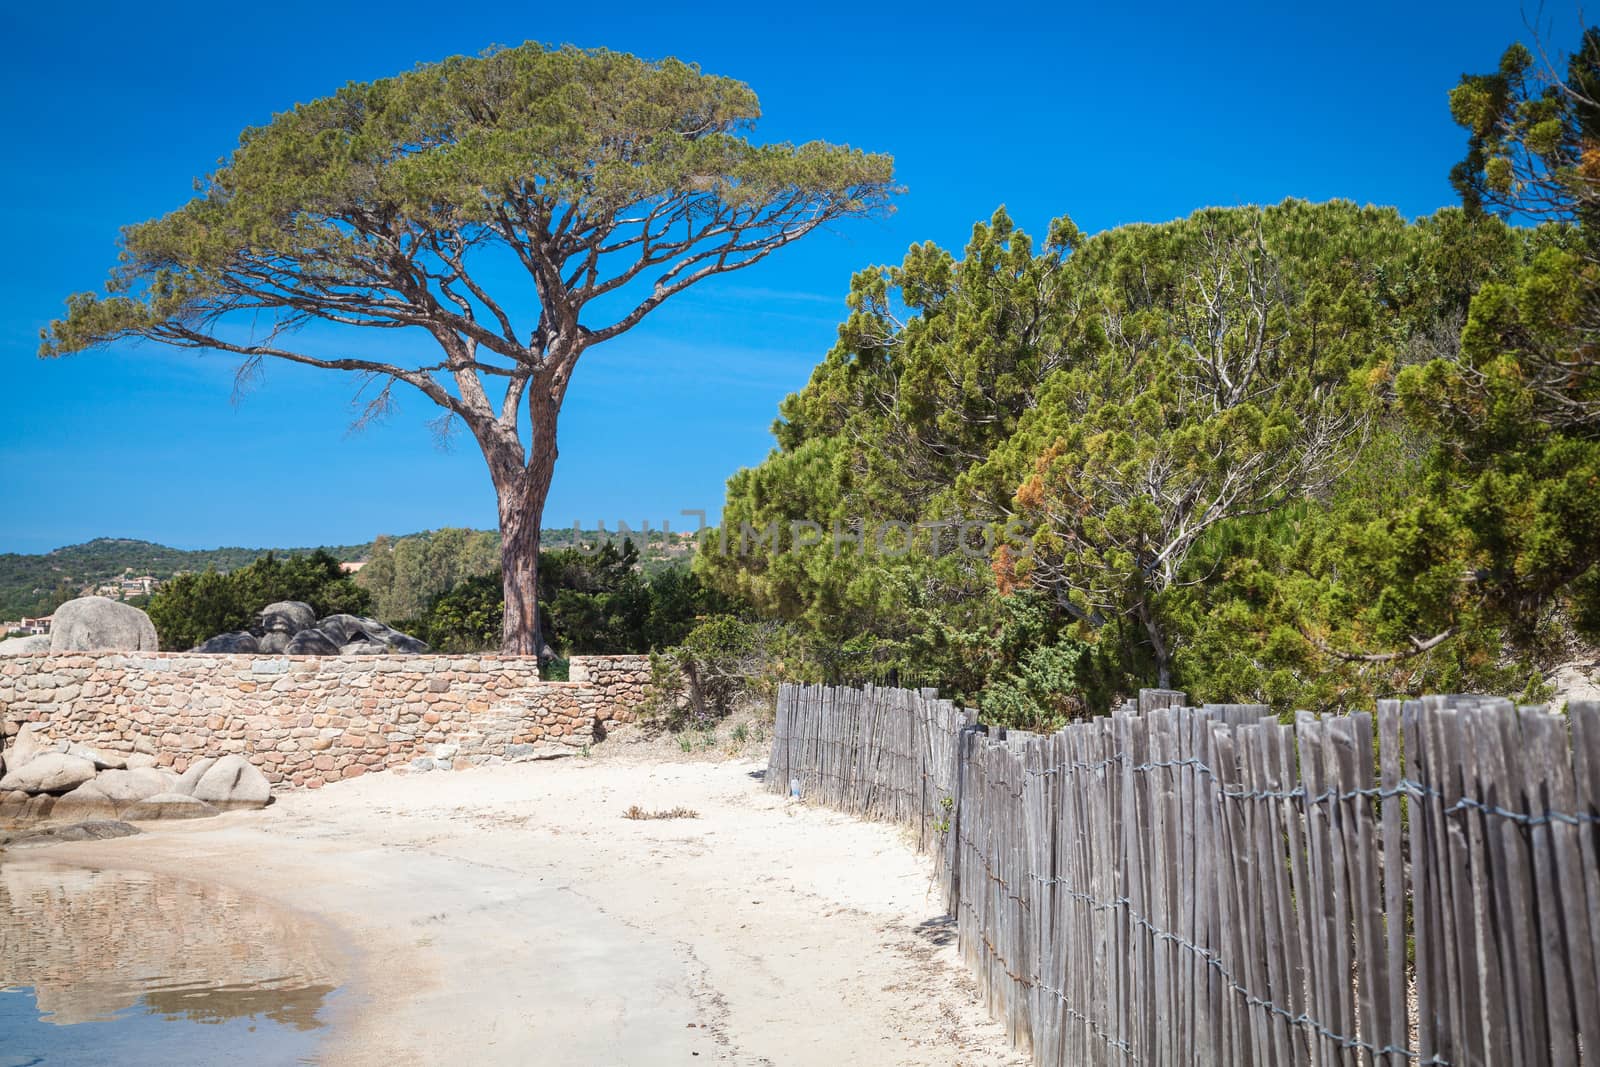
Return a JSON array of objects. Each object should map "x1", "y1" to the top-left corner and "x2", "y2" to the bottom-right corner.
[{"x1": 8, "y1": 758, "x2": 1026, "y2": 1065}]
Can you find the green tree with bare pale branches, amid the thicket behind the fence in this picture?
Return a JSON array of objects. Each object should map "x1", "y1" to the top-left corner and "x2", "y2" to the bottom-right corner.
[{"x1": 992, "y1": 202, "x2": 1414, "y2": 685}]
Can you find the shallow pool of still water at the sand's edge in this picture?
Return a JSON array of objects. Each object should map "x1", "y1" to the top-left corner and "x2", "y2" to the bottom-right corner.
[{"x1": 0, "y1": 857, "x2": 338, "y2": 1067}]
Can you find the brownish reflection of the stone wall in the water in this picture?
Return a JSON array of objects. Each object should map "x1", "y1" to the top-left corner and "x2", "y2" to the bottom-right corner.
[{"x1": 0, "y1": 859, "x2": 336, "y2": 1062}]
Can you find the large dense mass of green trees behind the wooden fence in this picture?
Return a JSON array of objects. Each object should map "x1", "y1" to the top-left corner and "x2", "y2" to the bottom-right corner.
[{"x1": 696, "y1": 187, "x2": 1580, "y2": 728}]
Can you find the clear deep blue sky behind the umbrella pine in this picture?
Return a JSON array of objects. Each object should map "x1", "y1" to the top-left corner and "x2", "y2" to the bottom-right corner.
[{"x1": 0, "y1": 0, "x2": 1578, "y2": 552}]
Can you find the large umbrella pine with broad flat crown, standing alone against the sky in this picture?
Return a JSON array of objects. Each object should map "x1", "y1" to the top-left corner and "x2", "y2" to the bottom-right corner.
[{"x1": 40, "y1": 43, "x2": 894, "y2": 654}]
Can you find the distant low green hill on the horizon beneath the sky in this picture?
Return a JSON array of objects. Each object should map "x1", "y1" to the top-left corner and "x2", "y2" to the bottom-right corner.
[{"x1": 0, "y1": 528, "x2": 700, "y2": 620}]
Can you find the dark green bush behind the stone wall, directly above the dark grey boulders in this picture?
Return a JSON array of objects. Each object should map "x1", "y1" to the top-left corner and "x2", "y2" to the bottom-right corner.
[{"x1": 147, "y1": 549, "x2": 371, "y2": 649}]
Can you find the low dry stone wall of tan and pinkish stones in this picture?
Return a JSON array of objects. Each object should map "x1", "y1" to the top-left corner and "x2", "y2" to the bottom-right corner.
[{"x1": 0, "y1": 651, "x2": 650, "y2": 789}]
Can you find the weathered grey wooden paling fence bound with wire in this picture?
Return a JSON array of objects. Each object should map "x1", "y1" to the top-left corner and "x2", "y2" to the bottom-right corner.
[{"x1": 766, "y1": 686, "x2": 1600, "y2": 1067}]
